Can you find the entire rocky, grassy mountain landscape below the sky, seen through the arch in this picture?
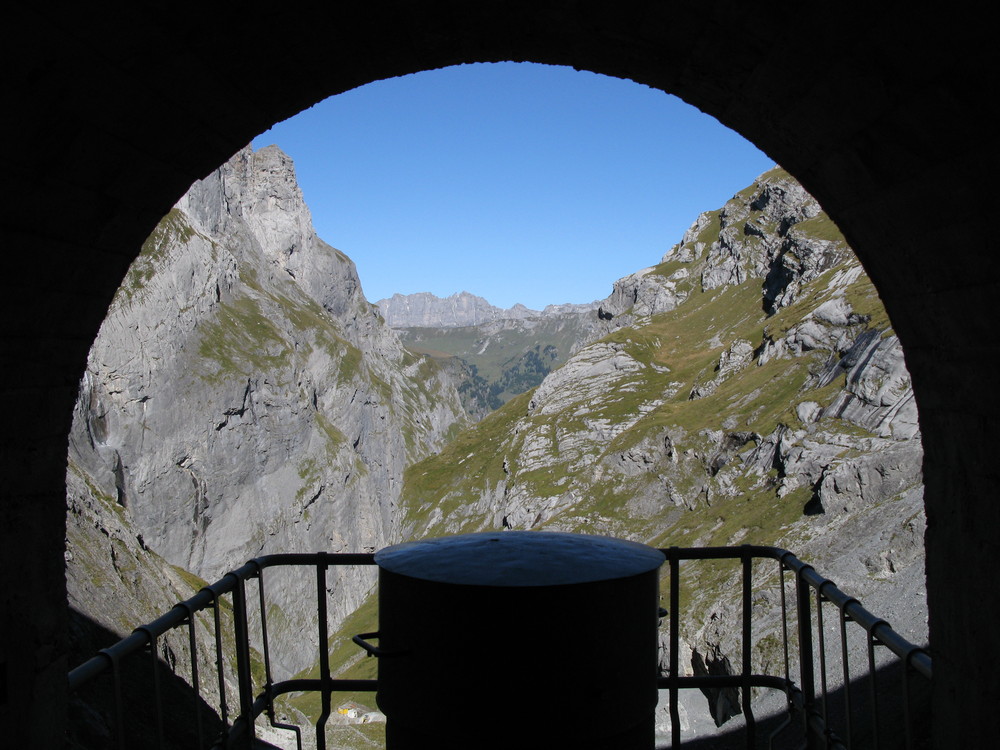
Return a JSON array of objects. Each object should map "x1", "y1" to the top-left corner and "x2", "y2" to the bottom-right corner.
[{"x1": 66, "y1": 146, "x2": 926, "y2": 748}]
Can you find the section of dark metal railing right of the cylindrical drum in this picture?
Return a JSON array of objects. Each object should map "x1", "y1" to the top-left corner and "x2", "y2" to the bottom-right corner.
[{"x1": 659, "y1": 545, "x2": 932, "y2": 750}]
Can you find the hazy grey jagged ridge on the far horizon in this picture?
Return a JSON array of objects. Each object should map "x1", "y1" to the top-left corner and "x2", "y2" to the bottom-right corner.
[{"x1": 375, "y1": 292, "x2": 598, "y2": 328}]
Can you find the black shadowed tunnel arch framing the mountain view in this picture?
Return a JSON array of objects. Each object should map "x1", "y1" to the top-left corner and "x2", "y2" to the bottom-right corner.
[{"x1": 0, "y1": 0, "x2": 1000, "y2": 748}]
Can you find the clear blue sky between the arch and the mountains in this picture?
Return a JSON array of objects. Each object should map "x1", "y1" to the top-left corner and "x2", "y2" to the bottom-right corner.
[{"x1": 254, "y1": 63, "x2": 774, "y2": 309}]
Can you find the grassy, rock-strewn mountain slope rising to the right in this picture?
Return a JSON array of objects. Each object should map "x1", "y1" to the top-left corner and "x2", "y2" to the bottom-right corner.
[{"x1": 403, "y1": 169, "x2": 926, "y2": 736}]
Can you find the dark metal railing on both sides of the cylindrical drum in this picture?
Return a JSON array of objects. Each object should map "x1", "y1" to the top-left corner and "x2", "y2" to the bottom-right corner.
[{"x1": 69, "y1": 545, "x2": 932, "y2": 750}]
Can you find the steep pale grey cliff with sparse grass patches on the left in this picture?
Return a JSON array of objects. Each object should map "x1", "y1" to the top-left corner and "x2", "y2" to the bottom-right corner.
[{"x1": 68, "y1": 147, "x2": 465, "y2": 671}]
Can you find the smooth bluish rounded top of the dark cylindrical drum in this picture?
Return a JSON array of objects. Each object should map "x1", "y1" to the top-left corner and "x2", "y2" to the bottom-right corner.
[{"x1": 375, "y1": 531, "x2": 665, "y2": 586}]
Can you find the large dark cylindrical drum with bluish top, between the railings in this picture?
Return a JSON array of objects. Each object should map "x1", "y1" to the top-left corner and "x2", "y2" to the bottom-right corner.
[{"x1": 375, "y1": 531, "x2": 664, "y2": 750}]
